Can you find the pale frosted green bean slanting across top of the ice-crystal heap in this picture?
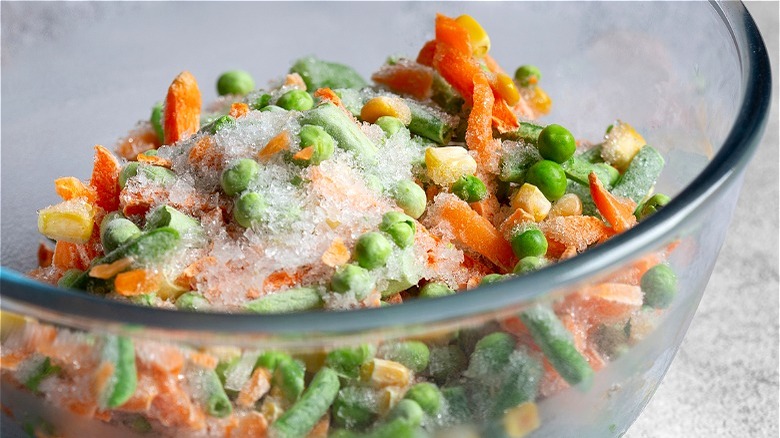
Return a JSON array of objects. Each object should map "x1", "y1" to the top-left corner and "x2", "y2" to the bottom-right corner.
[{"x1": 301, "y1": 102, "x2": 377, "y2": 164}]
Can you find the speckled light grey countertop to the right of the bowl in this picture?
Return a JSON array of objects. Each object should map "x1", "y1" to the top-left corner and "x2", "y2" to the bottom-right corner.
[{"x1": 627, "y1": 2, "x2": 780, "y2": 438}]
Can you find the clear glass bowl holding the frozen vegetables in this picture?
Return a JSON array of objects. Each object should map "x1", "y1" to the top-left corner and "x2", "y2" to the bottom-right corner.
[{"x1": 0, "y1": 2, "x2": 771, "y2": 436}]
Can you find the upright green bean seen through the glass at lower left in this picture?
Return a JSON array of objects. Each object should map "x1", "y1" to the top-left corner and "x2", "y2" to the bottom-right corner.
[{"x1": 99, "y1": 335, "x2": 138, "y2": 408}]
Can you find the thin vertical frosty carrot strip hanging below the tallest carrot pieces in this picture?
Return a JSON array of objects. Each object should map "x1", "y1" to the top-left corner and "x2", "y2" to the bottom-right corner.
[{"x1": 466, "y1": 72, "x2": 499, "y2": 173}]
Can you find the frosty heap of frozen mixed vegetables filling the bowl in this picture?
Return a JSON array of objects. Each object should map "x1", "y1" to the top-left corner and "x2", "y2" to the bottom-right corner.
[{"x1": 1, "y1": 15, "x2": 677, "y2": 437}]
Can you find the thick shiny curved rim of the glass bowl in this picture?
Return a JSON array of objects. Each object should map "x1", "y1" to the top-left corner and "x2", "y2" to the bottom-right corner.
[{"x1": 0, "y1": 1, "x2": 772, "y2": 341}]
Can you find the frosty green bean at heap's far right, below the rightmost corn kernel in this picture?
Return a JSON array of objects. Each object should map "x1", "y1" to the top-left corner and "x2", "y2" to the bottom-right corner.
[{"x1": 612, "y1": 145, "x2": 664, "y2": 203}]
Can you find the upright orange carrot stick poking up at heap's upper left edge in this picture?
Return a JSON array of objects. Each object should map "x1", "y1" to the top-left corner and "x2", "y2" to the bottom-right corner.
[{"x1": 163, "y1": 71, "x2": 201, "y2": 144}]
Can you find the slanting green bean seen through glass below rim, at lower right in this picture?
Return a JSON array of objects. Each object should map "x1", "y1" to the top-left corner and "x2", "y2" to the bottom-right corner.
[{"x1": 520, "y1": 305, "x2": 593, "y2": 388}]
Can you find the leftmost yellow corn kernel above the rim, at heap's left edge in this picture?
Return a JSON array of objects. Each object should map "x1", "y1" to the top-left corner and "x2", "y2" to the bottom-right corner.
[{"x1": 38, "y1": 198, "x2": 95, "y2": 243}]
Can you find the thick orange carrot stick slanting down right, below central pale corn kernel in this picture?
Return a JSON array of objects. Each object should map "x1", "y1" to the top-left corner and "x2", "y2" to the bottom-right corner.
[{"x1": 440, "y1": 196, "x2": 517, "y2": 272}]
